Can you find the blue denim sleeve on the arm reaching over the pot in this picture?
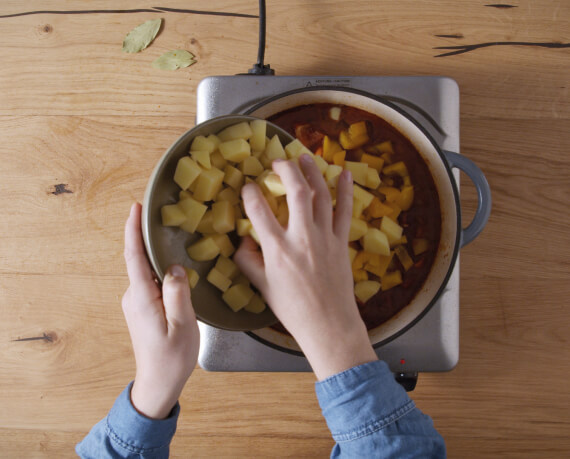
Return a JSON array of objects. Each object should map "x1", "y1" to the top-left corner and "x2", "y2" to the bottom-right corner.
[{"x1": 316, "y1": 361, "x2": 446, "y2": 459}]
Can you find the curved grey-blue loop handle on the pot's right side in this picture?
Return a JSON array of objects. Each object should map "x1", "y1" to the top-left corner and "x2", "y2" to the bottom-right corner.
[{"x1": 443, "y1": 151, "x2": 491, "y2": 247}]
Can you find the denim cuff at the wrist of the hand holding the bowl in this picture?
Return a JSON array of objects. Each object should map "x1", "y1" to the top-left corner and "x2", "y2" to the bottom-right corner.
[{"x1": 106, "y1": 382, "x2": 180, "y2": 454}]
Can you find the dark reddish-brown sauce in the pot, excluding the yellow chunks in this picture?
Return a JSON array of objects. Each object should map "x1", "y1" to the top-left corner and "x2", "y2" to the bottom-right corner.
[{"x1": 269, "y1": 104, "x2": 441, "y2": 331}]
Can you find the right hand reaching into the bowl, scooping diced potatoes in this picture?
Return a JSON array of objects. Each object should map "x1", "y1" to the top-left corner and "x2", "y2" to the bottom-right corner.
[{"x1": 234, "y1": 155, "x2": 377, "y2": 380}]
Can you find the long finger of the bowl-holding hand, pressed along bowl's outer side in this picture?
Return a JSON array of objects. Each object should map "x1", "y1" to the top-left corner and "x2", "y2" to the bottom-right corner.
[{"x1": 125, "y1": 203, "x2": 160, "y2": 295}]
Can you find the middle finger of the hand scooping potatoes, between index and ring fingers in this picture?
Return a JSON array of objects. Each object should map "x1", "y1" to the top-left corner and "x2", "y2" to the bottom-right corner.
[{"x1": 272, "y1": 161, "x2": 313, "y2": 228}]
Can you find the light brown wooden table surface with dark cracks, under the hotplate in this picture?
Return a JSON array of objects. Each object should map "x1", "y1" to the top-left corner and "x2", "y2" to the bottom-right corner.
[{"x1": 0, "y1": 0, "x2": 570, "y2": 458}]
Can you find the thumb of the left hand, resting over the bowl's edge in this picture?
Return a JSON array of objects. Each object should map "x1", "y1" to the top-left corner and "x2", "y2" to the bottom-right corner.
[{"x1": 162, "y1": 265, "x2": 196, "y2": 325}]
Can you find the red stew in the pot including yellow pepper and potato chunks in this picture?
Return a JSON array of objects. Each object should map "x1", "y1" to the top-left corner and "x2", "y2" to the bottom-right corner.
[{"x1": 269, "y1": 104, "x2": 441, "y2": 331}]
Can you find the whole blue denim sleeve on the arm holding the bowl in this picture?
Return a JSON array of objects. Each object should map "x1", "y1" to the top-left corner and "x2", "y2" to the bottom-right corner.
[{"x1": 75, "y1": 383, "x2": 180, "y2": 459}]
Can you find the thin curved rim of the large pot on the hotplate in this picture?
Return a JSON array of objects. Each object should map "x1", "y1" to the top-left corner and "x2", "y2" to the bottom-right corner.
[{"x1": 243, "y1": 86, "x2": 462, "y2": 356}]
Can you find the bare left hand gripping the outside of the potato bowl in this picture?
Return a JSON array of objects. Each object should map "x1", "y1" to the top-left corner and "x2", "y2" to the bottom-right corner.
[{"x1": 122, "y1": 203, "x2": 200, "y2": 419}]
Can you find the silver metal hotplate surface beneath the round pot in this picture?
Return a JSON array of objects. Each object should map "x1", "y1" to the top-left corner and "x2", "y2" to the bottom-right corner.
[{"x1": 196, "y1": 75, "x2": 459, "y2": 374}]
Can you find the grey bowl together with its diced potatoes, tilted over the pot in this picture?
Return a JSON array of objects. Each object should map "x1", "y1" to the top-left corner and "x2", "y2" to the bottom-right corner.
[{"x1": 142, "y1": 115, "x2": 298, "y2": 331}]
